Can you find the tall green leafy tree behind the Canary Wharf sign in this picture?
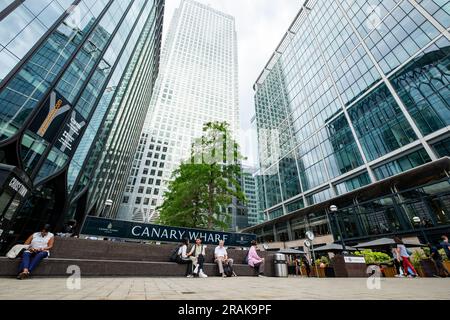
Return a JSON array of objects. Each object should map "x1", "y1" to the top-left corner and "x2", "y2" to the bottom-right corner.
[{"x1": 158, "y1": 122, "x2": 246, "y2": 230}]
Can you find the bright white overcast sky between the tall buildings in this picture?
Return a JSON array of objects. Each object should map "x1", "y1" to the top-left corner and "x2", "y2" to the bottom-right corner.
[{"x1": 163, "y1": 0, "x2": 303, "y2": 165}]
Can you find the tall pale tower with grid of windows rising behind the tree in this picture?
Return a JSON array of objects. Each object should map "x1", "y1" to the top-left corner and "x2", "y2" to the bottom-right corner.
[{"x1": 117, "y1": 0, "x2": 239, "y2": 222}]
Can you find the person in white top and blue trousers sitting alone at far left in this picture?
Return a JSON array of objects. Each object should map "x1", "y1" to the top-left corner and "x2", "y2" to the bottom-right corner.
[{"x1": 17, "y1": 224, "x2": 55, "y2": 280}]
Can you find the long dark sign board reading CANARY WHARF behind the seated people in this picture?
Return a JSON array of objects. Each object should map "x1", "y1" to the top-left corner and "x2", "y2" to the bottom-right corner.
[{"x1": 81, "y1": 216, "x2": 256, "y2": 247}]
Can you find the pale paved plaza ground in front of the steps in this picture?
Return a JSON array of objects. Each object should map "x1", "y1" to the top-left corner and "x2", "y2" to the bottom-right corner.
[{"x1": 0, "y1": 277, "x2": 450, "y2": 300}]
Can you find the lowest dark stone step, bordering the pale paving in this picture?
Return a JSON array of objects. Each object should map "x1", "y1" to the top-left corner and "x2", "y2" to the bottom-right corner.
[{"x1": 0, "y1": 257, "x2": 256, "y2": 277}]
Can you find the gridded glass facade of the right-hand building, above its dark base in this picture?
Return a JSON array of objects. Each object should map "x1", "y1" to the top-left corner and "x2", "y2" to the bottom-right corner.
[{"x1": 252, "y1": 0, "x2": 450, "y2": 242}]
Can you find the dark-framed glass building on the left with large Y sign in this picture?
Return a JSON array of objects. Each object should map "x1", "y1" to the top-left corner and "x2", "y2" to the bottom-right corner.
[{"x1": 0, "y1": 0, "x2": 164, "y2": 250}]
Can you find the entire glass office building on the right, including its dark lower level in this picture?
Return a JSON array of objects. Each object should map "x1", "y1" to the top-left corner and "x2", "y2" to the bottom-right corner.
[{"x1": 246, "y1": 0, "x2": 450, "y2": 245}]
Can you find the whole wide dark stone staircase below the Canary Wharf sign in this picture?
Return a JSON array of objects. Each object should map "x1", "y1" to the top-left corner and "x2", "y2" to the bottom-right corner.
[{"x1": 0, "y1": 237, "x2": 274, "y2": 277}]
